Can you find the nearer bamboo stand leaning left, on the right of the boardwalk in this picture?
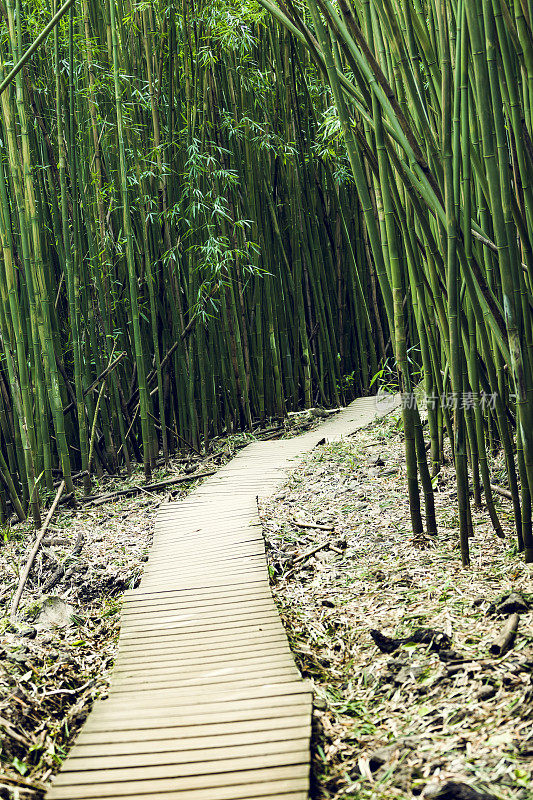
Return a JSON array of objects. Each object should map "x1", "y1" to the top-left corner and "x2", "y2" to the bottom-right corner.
[{"x1": 260, "y1": 0, "x2": 533, "y2": 565}]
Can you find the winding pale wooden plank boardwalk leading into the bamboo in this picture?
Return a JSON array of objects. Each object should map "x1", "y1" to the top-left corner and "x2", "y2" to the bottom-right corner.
[{"x1": 47, "y1": 398, "x2": 396, "y2": 800}]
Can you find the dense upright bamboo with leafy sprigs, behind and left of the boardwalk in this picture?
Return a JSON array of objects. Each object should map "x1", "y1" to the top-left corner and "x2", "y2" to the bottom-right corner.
[{"x1": 0, "y1": 0, "x2": 382, "y2": 525}]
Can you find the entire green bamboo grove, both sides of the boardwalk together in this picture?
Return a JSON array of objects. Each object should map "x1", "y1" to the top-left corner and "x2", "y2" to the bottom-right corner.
[{"x1": 0, "y1": 0, "x2": 533, "y2": 566}]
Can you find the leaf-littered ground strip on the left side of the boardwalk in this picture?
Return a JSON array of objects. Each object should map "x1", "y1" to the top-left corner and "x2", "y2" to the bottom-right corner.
[{"x1": 0, "y1": 413, "x2": 321, "y2": 800}]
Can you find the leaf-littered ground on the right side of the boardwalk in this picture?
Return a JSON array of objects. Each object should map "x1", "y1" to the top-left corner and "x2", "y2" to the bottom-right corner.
[{"x1": 261, "y1": 412, "x2": 533, "y2": 800}]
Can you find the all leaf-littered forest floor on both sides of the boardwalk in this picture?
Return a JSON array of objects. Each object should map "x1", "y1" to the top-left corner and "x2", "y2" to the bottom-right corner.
[{"x1": 0, "y1": 406, "x2": 533, "y2": 800}]
